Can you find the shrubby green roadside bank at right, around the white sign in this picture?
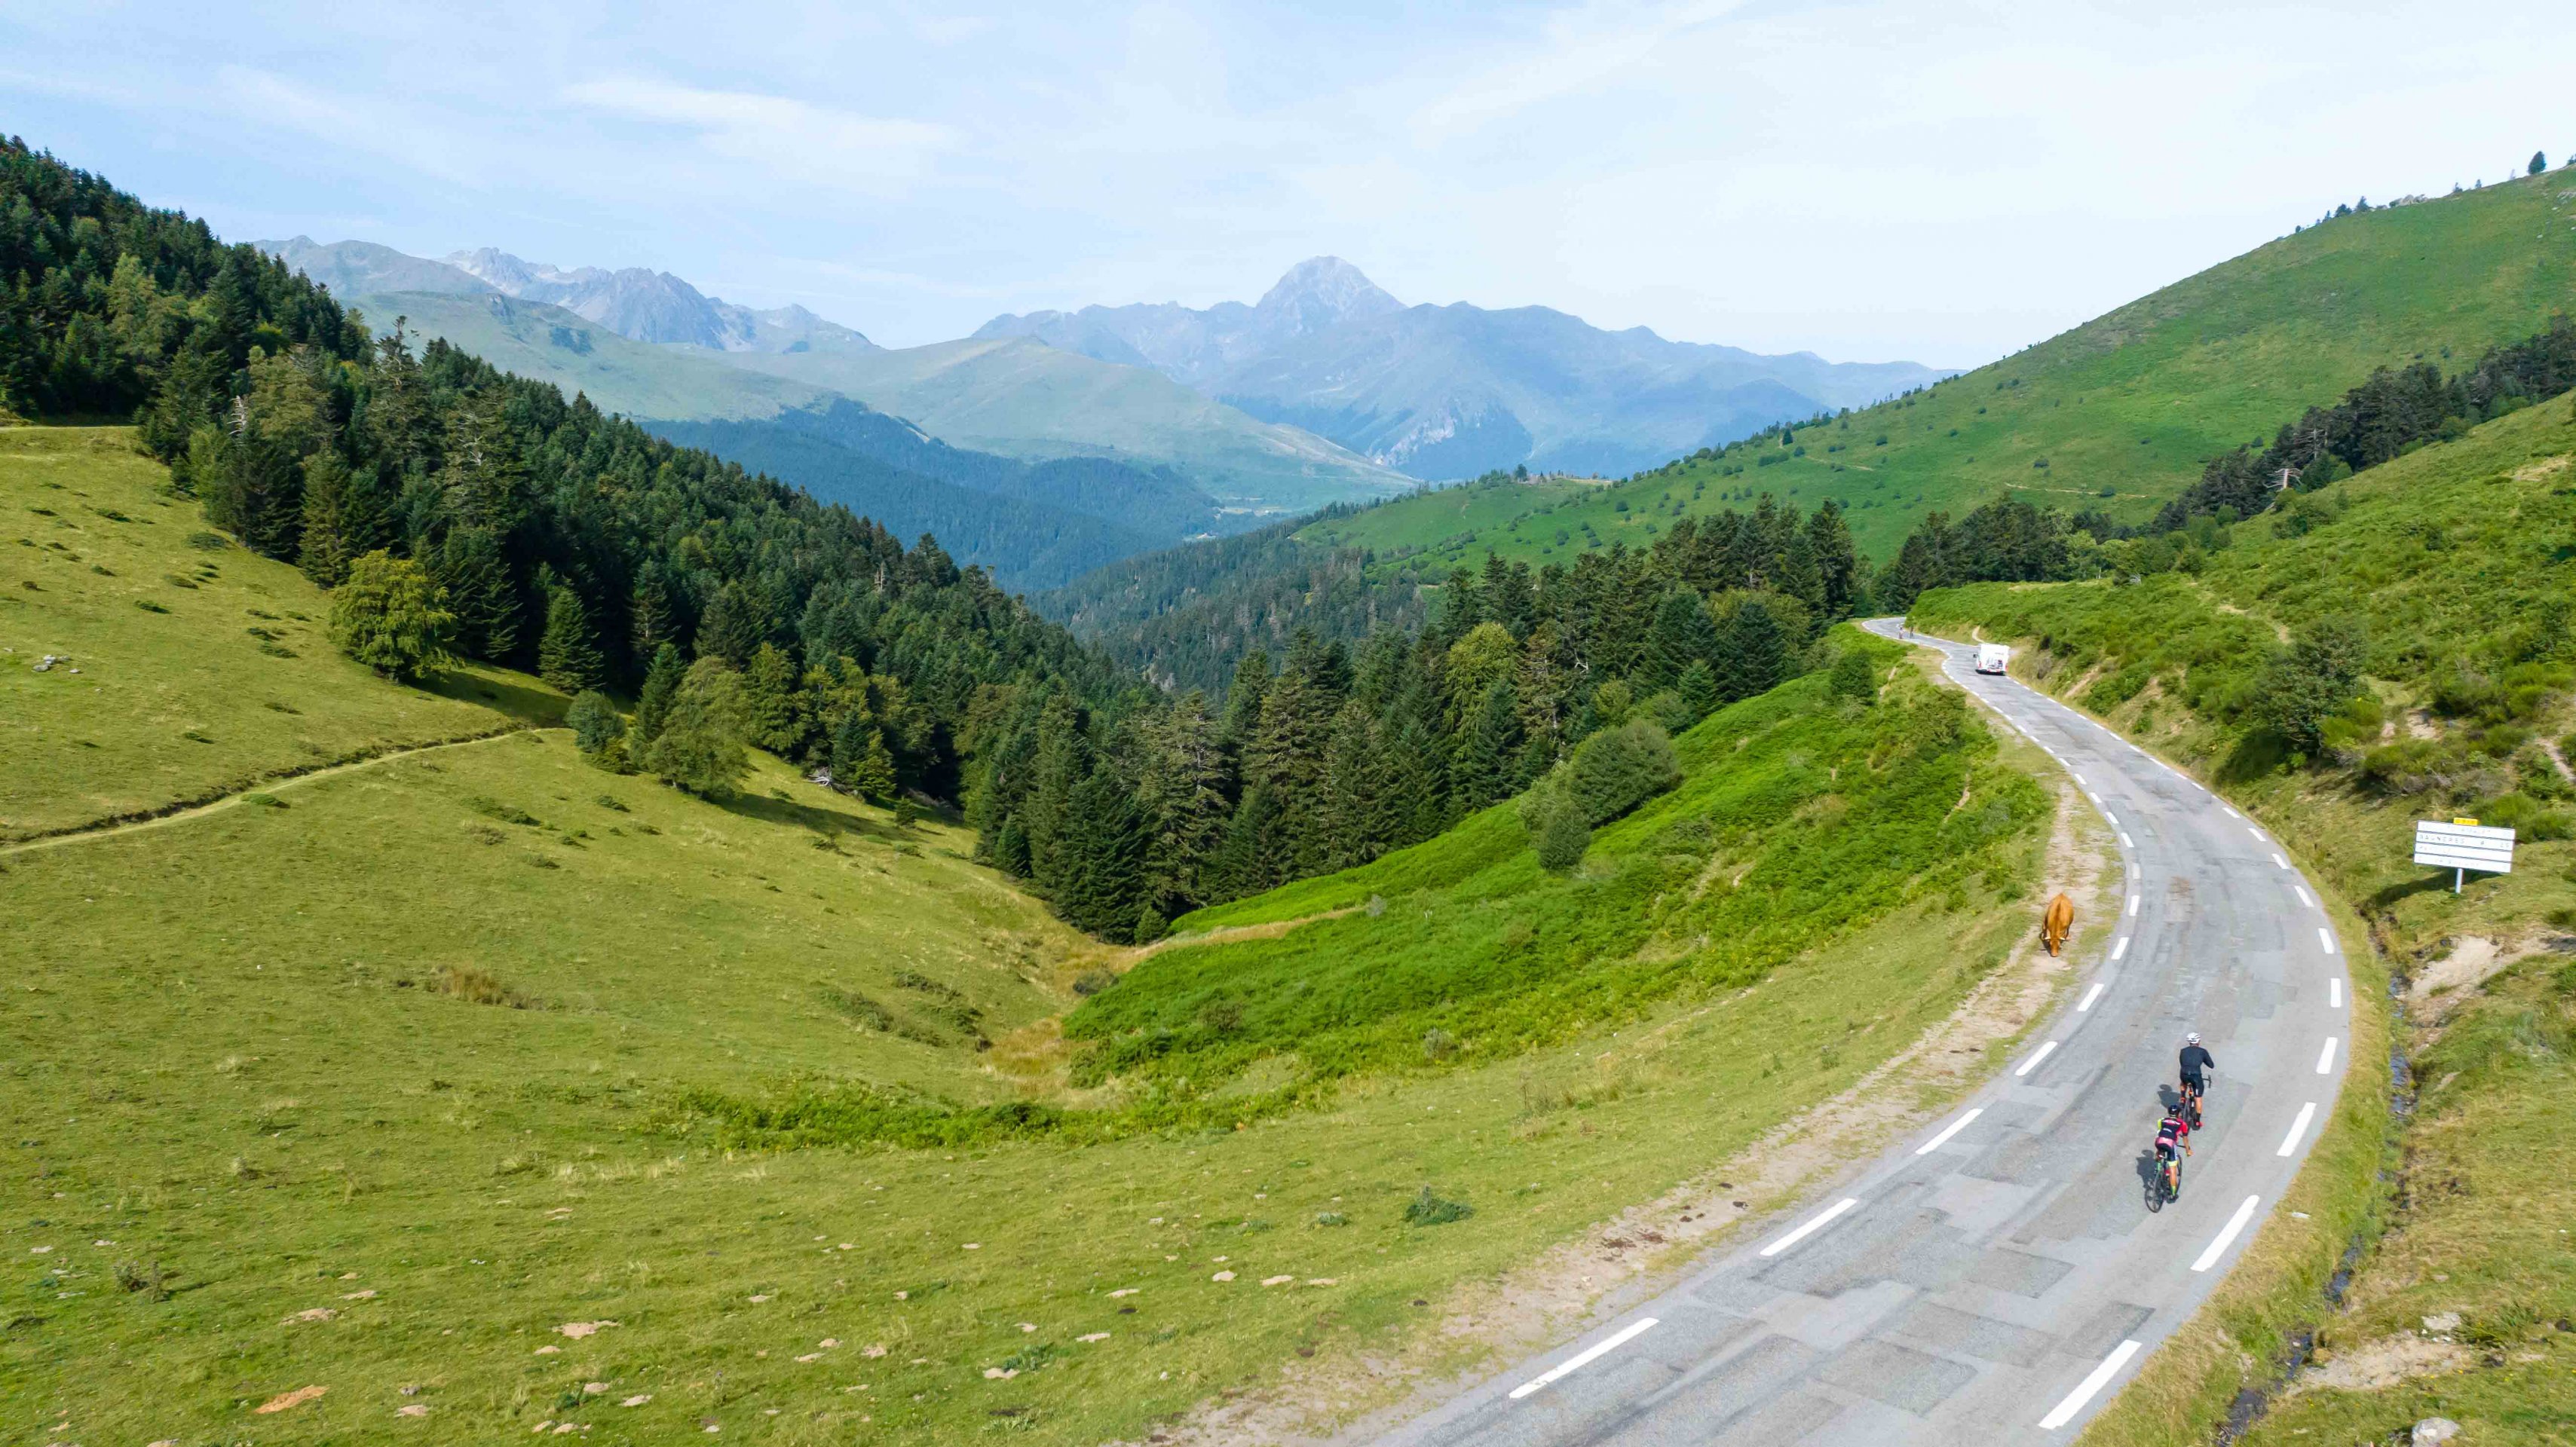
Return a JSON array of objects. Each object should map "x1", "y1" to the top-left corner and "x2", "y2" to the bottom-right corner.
[{"x1": 1914, "y1": 388, "x2": 2576, "y2": 1447}]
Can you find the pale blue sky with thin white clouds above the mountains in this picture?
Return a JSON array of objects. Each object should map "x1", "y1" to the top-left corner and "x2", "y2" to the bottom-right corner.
[{"x1": 0, "y1": 0, "x2": 2576, "y2": 366}]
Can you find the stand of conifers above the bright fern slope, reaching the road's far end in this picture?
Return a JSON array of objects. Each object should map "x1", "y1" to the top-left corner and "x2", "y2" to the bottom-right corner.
[{"x1": 969, "y1": 497, "x2": 1867, "y2": 940}]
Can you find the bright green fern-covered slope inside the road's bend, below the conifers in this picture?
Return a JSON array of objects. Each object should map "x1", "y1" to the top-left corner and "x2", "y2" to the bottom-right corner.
[{"x1": 1067, "y1": 631, "x2": 2045, "y2": 1087}]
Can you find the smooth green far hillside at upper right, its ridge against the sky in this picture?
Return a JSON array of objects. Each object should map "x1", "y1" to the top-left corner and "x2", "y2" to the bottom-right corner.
[{"x1": 1314, "y1": 173, "x2": 2576, "y2": 561}]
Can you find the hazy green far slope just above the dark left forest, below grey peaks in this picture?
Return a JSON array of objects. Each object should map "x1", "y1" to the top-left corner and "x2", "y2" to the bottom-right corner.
[{"x1": 351, "y1": 291, "x2": 829, "y2": 422}]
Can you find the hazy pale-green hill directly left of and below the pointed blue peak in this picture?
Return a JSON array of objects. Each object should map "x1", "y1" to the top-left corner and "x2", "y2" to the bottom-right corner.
[{"x1": 700, "y1": 340, "x2": 1414, "y2": 512}]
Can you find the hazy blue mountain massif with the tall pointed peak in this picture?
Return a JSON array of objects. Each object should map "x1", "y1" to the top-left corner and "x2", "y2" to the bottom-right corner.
[{"x1": 976, "y1": 258, "x2": 1947, "y2": 479}]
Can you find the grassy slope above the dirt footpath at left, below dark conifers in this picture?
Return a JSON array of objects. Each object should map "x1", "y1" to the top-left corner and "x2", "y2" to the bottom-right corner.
[{"x1": 0, "y1": 427, "x2": 543, "y2": 842}]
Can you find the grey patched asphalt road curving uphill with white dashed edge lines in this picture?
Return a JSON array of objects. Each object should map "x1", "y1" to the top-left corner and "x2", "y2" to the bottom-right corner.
[{"x1": 1378, "y1": 618, "x2": 2352, "y2": 1447}]
